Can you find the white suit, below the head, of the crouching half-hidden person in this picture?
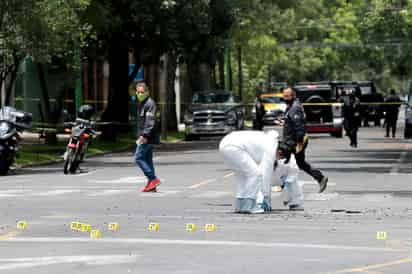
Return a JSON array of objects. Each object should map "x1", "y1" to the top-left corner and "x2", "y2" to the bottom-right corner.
[{"x1": 275, "y1": 154, "x2": 304, "y2": 210}]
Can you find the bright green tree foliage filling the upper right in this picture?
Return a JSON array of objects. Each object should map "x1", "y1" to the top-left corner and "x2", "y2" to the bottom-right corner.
[{"x1": 231, "y1": 0, "x2": 412, "y2": 98}]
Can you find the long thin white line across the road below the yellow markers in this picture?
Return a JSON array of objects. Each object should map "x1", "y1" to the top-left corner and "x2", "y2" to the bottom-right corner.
[{"x1": 0, "y1": 237, "x2": 408, "y2": 253}]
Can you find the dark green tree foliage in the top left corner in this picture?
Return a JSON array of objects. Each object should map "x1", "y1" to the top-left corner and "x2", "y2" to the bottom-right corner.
[{"x1": 0, "y1": 0, "x2": 91, "y2": 77}]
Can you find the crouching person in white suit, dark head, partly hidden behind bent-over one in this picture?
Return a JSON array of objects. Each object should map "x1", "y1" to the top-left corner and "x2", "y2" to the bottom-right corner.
[{"x1": 274, "y1": 143, "x2": 304, "y2": 211}]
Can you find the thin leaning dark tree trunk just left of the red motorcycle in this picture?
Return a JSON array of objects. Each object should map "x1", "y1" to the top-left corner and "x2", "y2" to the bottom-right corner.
[{"x1": 37, "y1": 63, "x2": 58, "y2": 144}]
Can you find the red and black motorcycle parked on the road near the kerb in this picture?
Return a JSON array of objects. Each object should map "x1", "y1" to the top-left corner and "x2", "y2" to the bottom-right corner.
[{"x1": 63, "y1": 118, "x2": 96, "y2": 174}]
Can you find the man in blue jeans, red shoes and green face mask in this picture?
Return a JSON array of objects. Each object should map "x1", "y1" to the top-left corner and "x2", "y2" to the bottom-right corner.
[{"x1": 135, "y1": 83, "x2": 160, "y2": 192}]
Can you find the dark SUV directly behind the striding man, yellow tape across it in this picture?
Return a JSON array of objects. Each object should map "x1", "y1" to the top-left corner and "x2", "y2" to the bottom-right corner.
[{"x1": 293, "y1": 82, "x2": 343, "y2": 138}]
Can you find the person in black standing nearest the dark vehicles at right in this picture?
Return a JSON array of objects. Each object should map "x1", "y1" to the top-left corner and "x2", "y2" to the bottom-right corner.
[{"x1": 343, "y1": 92, "x2": 361, "y2": 147}]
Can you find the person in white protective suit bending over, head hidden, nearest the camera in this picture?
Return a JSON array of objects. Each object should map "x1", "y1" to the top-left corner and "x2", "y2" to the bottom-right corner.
[{"x1": 219, "y1": 131, "x2": 278, "y2": 214}]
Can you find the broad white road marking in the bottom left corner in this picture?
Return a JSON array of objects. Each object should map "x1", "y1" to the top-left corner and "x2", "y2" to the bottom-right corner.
[{"x1": 0, "y1": 255, "x2": 138, "y2": 270}]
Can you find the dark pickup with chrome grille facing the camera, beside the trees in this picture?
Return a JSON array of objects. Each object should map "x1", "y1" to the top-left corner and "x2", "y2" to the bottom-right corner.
[{"x1": 184, "y1": 90, "x2": 245, "y2": 140}]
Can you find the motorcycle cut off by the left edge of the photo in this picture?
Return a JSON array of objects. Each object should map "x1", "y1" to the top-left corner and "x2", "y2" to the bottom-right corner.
[{"x1": 0, "y1": 107, "x2": 33, "y2": 175}]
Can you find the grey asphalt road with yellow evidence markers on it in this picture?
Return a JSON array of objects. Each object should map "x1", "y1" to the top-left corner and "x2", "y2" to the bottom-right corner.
[{"x1": 0, "y1": 122, "x2": 412, "y2": 274}]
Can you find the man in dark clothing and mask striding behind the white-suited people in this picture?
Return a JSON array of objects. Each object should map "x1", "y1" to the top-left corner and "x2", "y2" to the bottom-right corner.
[{"x1": 283, "y1": 88, "x2": 328, "y2": 193}]
